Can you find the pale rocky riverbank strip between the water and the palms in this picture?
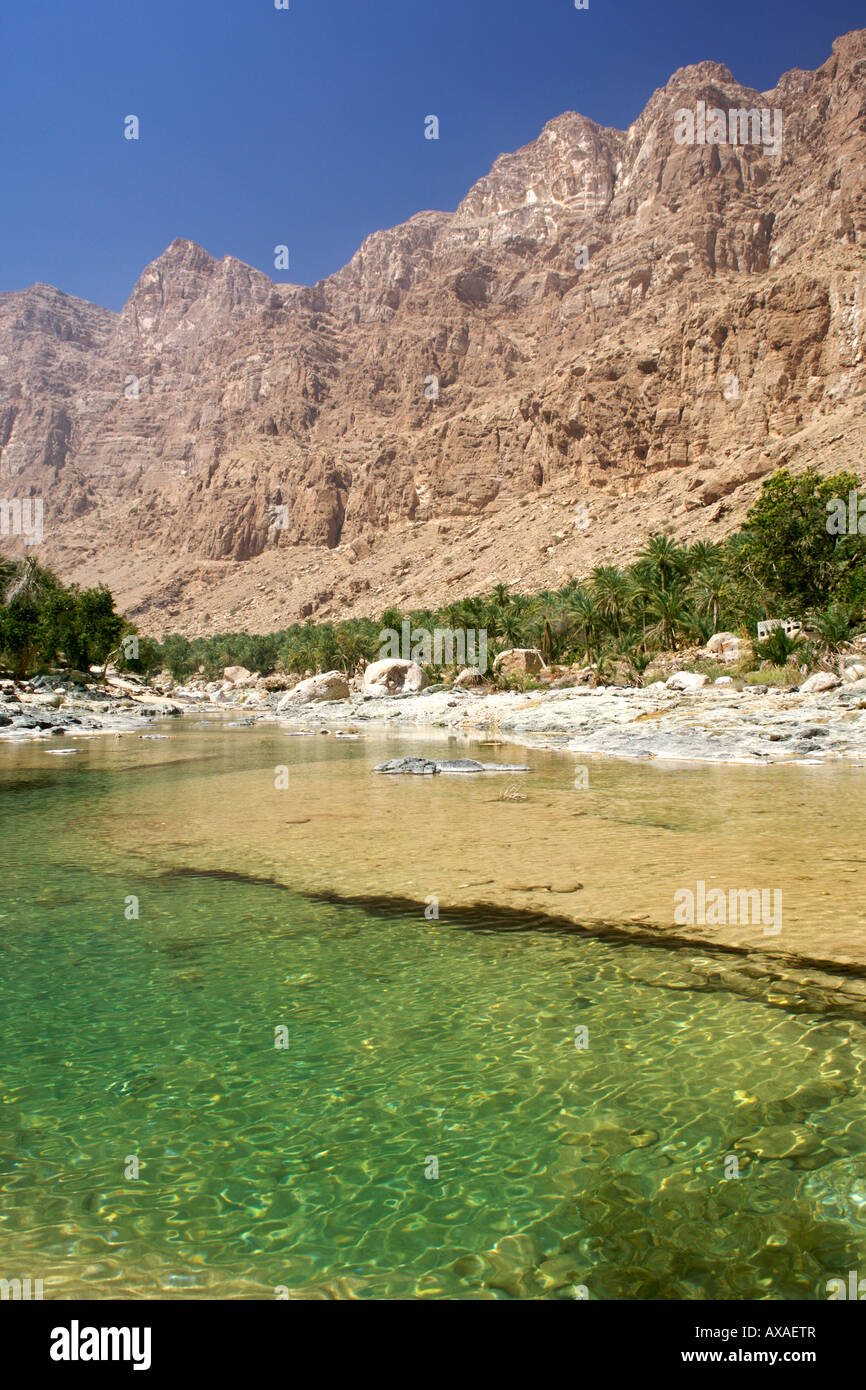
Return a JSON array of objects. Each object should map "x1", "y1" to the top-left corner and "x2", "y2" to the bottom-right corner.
[{"x1": 0, "y1": 677, "x2": 866, "y2": 765}]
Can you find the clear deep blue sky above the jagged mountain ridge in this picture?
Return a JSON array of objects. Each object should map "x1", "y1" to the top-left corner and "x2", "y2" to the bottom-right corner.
[{"x1": 0, "y1": 0, "x2": 866, "y2": 309}]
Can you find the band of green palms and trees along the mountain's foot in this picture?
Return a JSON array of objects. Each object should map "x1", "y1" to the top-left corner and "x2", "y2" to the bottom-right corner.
[{"x1": 0, "y1": 471, "x2": 866, "y2": 680}]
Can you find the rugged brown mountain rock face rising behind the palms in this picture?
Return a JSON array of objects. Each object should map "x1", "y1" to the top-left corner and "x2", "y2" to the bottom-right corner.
[{"x1": 0, "y1": 31, "x2": 866, "y2": 632}]
